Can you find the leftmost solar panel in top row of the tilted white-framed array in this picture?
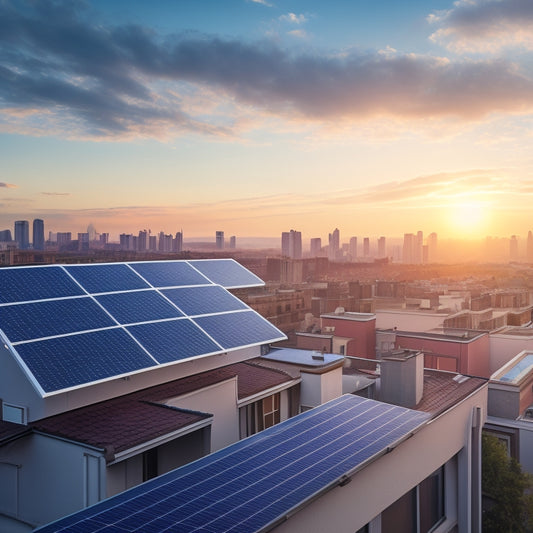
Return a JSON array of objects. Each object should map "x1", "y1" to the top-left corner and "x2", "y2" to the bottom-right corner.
[{"x1": 0, "y1": 266, "x2": 85, "y2": 303}]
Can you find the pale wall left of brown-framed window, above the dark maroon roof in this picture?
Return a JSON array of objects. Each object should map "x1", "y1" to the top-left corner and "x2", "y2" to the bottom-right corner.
[{"x1": 165, "y1": 377, "x2": 239, "y2": 452}]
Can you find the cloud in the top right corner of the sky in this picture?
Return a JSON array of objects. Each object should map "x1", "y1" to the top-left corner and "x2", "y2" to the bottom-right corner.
[{"x1": 428, "y1": 0, "x2": 533, "y2": 52}]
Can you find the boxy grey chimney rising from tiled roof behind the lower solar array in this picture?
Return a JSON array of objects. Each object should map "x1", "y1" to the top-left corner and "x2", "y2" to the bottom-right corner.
[{"x1": 380, "y1": 350, "x2": 424, "y2": 408}]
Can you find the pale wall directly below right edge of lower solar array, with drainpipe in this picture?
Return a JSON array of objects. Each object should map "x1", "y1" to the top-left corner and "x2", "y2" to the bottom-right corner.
[{"x1": 276, "y1": 387, "x2": 487, "y2": 533}]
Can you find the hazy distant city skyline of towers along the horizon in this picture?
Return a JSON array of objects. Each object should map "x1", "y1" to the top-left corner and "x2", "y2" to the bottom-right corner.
[{"x1": 0, "y1": 219, "x2": 533, "y2": 264}]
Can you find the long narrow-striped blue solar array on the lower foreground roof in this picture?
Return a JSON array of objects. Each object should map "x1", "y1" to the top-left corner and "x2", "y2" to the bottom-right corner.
[{"x1": 38, "y1": 395, "x2": 430, "y2": 533}]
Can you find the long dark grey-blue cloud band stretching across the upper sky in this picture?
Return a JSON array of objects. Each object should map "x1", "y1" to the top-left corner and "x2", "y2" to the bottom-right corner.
[{"x1": 0, "y1": 0, "x2": 533, "y2": 136}]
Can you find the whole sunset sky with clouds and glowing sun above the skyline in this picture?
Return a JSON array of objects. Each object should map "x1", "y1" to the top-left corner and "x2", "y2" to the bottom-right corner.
[{"x1": 0, "y1": 0, "x2": 533, "y2": 242}]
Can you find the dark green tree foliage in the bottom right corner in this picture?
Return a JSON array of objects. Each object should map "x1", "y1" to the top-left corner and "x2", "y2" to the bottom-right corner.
[{"x1": 481, "y1": 434, "x2": 533, "y2": 533}]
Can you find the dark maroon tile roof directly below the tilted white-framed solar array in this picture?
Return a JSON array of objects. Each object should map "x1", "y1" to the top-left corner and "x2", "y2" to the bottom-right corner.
[{"x1": 4, "y1": 361, "x2": 294, "y2": 459}]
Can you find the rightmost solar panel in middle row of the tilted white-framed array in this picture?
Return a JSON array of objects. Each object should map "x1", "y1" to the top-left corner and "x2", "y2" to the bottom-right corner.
[{"x1": 161, "y1": 285, "x2": 248, "y2": 316}]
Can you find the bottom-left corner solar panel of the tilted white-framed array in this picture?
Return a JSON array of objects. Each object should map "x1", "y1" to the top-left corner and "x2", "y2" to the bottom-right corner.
[{"x1": 16, "y1": 329, "x2": 156, "y2": 392}]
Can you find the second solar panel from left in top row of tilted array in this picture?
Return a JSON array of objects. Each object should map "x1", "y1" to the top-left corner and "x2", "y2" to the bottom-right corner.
[{"x1": 65, "y1": 263, "x2": 148, "y2": 293}]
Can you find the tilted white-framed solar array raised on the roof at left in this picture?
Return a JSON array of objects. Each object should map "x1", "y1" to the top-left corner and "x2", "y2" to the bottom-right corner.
[{"x1": 0, "y1": 259, "x2": 285, "y2": 396}]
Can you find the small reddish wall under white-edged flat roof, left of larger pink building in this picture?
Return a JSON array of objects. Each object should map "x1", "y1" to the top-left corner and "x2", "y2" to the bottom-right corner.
[{"x1": 321, "y1": 315, "x2": 376, "y2": 358}]
